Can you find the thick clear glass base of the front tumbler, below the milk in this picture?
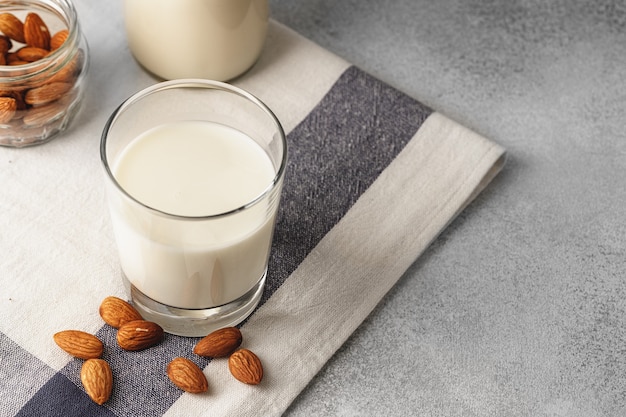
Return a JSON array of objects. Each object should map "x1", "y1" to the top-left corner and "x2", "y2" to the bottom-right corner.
[{"x1": 122, "y1": 271, "x2": 267, "y2": 337}]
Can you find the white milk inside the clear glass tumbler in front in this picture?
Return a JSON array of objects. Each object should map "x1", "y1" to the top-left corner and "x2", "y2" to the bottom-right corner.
[{"x1": 112, "y1": 121, "x2": 276, "y2": 308}]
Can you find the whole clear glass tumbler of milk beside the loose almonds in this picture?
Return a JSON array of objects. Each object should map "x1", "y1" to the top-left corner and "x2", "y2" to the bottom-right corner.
[{"x1": 100, "y1": 79, "x2": 287, "y2": 336}]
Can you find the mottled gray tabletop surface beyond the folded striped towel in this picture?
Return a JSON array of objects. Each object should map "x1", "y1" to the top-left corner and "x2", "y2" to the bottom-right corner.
[{"x1": 271, "y1": 0, "x2": 626, "y2": 417}]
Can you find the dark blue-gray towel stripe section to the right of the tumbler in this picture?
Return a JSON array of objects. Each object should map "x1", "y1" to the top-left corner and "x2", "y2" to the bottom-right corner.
[{"x1": 261, "y1": 62, "x2": 432, "y2": 302}]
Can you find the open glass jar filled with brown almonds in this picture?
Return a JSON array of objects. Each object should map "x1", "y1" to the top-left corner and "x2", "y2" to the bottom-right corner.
[{"x1": 0, "y1": 0, "x2": 89, "y2": 147}]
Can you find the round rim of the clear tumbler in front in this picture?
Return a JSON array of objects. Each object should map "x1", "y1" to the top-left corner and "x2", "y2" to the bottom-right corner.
[{"x1": 100, "y1": 78, "x2": 287, "y2": 220}]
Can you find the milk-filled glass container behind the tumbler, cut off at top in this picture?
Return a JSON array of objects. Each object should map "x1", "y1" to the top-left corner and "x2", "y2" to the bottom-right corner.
[{"x1": 122, "y1": 0, "x2": 269, "y2": 81}]
